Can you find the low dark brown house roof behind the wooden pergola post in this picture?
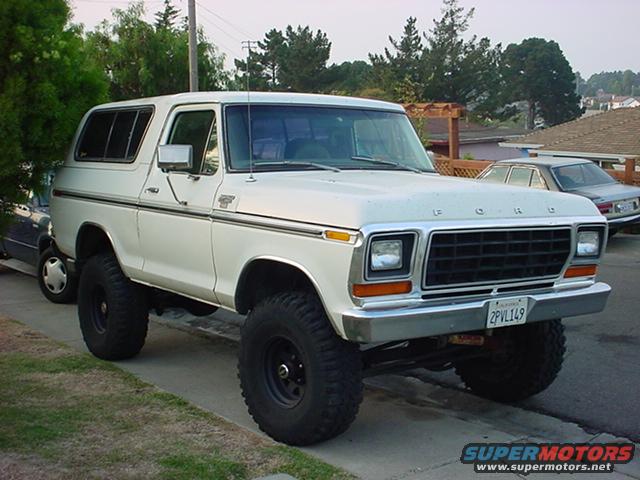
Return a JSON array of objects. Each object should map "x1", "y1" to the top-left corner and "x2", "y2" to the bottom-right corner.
[{"x1": 424, "y1": 118, "x2": 525, "y2": 145}]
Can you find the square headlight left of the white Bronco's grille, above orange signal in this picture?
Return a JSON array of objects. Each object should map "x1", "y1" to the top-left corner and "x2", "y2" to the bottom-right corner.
[{"x1": 365, "y1": 232, "x2": 417, "y2": 280}]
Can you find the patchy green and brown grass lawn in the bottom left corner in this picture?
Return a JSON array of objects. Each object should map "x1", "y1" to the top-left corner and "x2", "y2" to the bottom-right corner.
[{"x1": 0, "y1": 317, "x2": 352, "y2": 480}]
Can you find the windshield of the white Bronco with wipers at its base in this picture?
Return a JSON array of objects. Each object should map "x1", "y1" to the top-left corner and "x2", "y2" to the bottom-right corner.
[{"x1": 225, "y1": 105, "x2": 434, "y2": 172}]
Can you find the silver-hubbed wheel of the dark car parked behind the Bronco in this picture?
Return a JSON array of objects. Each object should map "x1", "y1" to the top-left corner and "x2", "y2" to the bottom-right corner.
[{"x1": 37, "y1": 246, "x2": 78, "y2": 303}]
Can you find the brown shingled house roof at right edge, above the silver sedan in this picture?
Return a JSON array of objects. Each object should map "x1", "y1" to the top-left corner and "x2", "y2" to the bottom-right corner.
[{"x1": 500, "y1": 107, "x2": 640, "y2": 158}]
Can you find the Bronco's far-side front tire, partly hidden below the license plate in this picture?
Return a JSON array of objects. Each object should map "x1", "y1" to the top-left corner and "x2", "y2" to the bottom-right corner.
[{"x1": 455, "y1": 320, "x2": 566, "y2": 402}]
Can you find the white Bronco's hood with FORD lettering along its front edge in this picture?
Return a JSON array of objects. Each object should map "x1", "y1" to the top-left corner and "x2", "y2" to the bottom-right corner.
[{"x1": 222, "y1": 170, "x2": 600, "y2": 229}]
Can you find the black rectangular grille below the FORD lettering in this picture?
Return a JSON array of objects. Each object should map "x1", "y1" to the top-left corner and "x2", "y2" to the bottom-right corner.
[{"x1": 425, "y1": 228, "x2": 571, "y2": 289}]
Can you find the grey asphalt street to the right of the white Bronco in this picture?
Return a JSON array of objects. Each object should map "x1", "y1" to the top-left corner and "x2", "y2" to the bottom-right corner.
[{"x1": 416, "y1": 235, "x2": 640, "y2": 442}]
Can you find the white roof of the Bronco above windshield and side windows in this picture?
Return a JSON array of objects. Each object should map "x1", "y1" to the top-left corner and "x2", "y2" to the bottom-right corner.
[{"x1": 91, "y1": 92, "x2": 404, "y2": 112}]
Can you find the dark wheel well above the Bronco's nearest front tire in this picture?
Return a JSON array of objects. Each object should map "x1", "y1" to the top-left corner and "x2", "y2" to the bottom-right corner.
[{"x1": 235, "y1": 259, "x2": 318, "y2": 315}]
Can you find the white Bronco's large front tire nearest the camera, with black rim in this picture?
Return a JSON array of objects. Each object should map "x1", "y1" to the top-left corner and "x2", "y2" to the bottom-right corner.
[{"x1": 238, "y1": 293, "x2": 363, "y2": 445}]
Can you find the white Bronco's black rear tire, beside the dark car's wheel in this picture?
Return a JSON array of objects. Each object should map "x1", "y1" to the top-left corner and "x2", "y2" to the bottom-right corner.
[{"x1": 78, "y1": 253, "x2": 149, "y2": 360}]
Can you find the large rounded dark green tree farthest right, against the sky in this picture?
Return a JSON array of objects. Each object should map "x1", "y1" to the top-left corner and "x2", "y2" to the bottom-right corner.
[{"x1": 502, "y1": 38, "x2": 582, "y2": 128}]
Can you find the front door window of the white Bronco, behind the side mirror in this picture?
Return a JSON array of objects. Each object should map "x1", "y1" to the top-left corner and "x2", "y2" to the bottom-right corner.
[{"x1": 167, "y1": 110, "x2": 220, "y2": 175}]
